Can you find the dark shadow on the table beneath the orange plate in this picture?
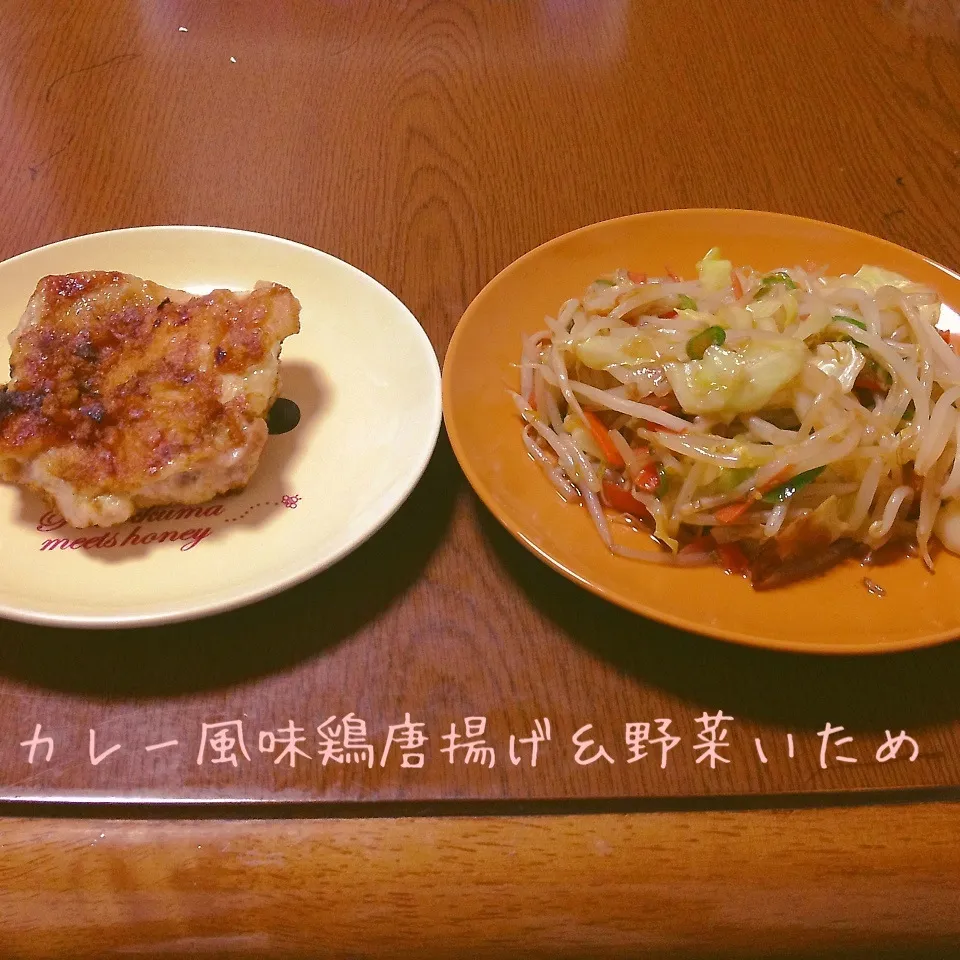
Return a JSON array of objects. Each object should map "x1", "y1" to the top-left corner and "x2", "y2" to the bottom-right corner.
[{"x1": 475, "y1": 502, "x2": 960, "y2": 729}]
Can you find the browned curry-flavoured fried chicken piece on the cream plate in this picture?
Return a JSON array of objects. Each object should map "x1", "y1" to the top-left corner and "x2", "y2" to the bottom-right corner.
[{"x1": 0, "y1": 271, "x2": 300, "y2": 527}]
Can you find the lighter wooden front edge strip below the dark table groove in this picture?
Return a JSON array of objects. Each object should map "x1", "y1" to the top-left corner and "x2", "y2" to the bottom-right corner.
[{"x1": 0, "y1": 805, "x2": 960, "y2": 960}]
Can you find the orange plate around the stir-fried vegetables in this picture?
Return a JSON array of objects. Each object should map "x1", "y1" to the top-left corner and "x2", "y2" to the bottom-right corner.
[{"x1": 443, "y1": 210, "x2": 960, "y2": 653}]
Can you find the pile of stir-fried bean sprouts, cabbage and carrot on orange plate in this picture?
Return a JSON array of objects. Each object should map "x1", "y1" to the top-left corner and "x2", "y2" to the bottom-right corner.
[{"x1": 515, "y1": 248, "x2": 960, "y2": 589}]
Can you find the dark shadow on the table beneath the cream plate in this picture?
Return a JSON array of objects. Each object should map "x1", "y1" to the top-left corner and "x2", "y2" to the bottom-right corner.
[{"x1": 0, "y1": 433, "x2": 462, "y2": 699}]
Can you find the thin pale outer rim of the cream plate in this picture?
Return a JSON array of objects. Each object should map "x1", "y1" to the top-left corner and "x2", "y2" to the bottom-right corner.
[{"x1": 0, "y1": 223, "x2": 443, "y2": 630}]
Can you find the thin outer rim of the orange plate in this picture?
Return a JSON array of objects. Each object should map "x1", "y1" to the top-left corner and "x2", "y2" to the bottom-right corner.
[{"x1": 441, "y1": 207, "x2": 960, "y2": 657}]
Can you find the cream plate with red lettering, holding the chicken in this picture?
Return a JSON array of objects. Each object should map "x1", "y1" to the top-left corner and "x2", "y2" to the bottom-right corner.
[{"x1": 0, "y1": 227, "x2": 440, "y2": 628}]
